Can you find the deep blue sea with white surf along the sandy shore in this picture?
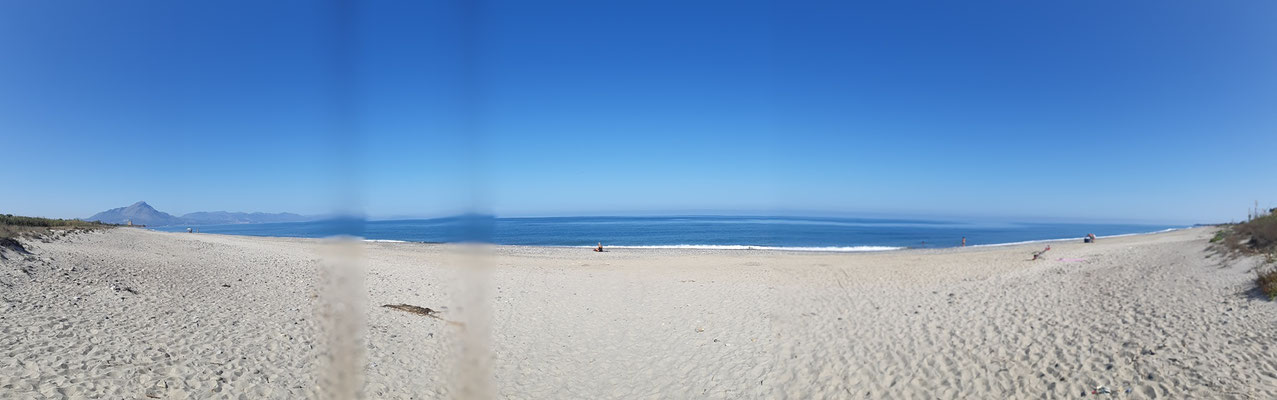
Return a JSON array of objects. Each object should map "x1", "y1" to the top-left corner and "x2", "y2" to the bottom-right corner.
[{"x1": 155, "y1": 216, "x2": 1189, "y2": 252}]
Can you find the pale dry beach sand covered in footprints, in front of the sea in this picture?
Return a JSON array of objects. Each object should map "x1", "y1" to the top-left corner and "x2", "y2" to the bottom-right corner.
[{"x1": 0, "y1": 229, "x2": 1277, "y2": 399}]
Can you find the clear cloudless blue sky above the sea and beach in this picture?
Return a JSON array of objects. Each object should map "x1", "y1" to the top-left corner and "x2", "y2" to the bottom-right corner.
[{"x1": 0, "y1": 1, "x2": 1277, "y2": 222}]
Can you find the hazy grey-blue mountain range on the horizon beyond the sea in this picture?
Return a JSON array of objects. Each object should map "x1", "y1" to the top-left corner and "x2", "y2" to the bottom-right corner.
[{"x1": 84, "y1": 202, "x2": 315, "y2": 226}]
